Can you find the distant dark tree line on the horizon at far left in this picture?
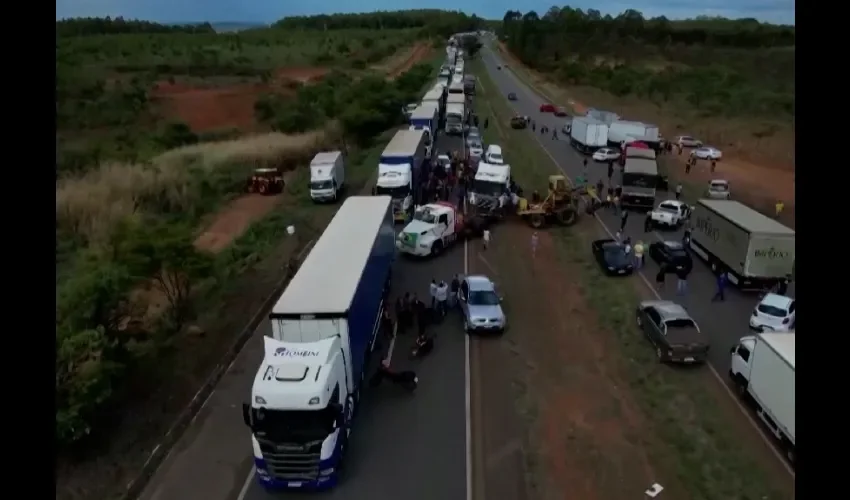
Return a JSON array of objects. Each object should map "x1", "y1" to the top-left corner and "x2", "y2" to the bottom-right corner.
[{"x1": 56, "y1": 16, "x2": 215, "y2": 37}]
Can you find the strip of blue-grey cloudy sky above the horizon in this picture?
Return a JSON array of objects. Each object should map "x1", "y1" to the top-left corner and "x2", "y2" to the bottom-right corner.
[{"x1": 56, "y1": 0, "x2": 795, "y2": 24}]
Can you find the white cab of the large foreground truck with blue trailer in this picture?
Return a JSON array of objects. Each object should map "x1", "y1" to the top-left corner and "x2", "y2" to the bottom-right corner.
[{"x1": 242, "y1": 337, "x2": 354, "y2": 488}]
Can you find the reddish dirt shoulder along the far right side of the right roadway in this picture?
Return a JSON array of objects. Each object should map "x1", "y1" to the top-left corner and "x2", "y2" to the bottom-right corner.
[{"x1": 498, "y1": 43, "x2": 796, "y2": 227}]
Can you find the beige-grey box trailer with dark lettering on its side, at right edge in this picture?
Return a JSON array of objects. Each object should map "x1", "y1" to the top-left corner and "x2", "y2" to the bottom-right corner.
[{"x1": 690, "y1": 199, "x2": 796, "y2": 290}]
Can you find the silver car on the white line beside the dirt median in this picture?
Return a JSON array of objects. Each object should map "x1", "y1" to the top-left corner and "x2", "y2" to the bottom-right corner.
[{"x1": 458, "y1": 274, "x2": 507, "y2": 333}]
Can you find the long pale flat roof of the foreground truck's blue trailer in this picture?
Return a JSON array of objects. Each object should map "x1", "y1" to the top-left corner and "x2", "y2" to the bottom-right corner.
[{"x1": 272, "y1": 196, "x2": 391, "y2": 314}]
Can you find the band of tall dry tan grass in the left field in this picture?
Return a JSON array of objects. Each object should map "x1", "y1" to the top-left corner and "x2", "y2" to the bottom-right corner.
[{"x1": 56, "y1": 124, "x2": 338, "y2": 244}]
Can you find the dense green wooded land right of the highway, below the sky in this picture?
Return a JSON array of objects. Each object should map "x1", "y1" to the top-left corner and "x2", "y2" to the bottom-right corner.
[{"x1": 499, "y1": 7, "x2": 795, "y2": 118}]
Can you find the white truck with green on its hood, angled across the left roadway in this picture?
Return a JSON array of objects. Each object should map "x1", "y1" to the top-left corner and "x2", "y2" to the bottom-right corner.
[{"x1": 396, "y1": 201, "x2": 463, "y2": 257}]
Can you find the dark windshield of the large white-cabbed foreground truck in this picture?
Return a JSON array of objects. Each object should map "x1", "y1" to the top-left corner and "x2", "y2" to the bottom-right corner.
[{"x1": 252, "y1": 408, "x2": 337, "y2": 442}]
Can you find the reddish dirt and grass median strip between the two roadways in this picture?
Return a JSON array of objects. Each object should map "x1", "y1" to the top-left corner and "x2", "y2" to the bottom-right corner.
[{"x1": 470, "y1": 223, "x2": 690, "y2": 500}]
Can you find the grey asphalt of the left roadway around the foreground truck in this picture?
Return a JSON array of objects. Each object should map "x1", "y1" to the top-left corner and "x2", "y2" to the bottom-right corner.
[{"x1": 142, "y1": 137, "x2": 466, "y2": 500}]
